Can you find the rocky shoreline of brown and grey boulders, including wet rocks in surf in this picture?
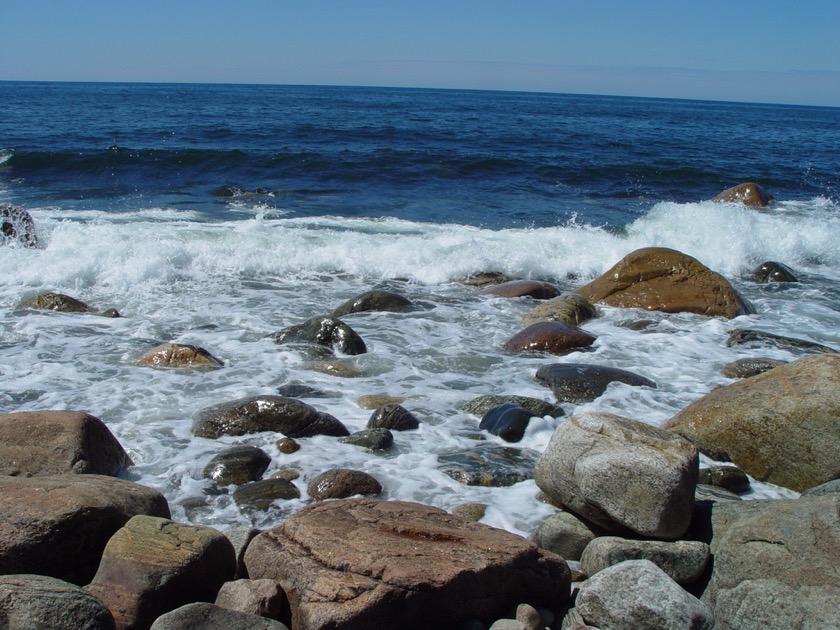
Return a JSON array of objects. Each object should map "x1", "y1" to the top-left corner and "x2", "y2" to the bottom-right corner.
[{"x1": 0, "y1": 190, "x2": 840, "y2": 630}]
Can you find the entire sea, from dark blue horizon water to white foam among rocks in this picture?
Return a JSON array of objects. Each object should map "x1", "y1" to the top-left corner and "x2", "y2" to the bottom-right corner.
[{"x1": 0, "y1": 82, "x2": 840, "y2": 535}]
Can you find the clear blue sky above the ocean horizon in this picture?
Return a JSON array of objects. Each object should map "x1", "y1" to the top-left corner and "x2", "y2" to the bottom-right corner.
[{"x1": 0, "y1": 0, "x2": 840, "y2": 106}]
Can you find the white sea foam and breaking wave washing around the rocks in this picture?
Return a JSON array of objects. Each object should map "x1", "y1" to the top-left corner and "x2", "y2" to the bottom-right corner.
[{"x1": 0, "y1": 199, "x2": 828, "y2": 534}]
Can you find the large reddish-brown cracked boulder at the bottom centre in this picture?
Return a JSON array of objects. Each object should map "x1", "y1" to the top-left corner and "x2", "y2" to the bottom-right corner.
[{"x1": 245, "y1": 499, "x2": 570, "y2": 630}]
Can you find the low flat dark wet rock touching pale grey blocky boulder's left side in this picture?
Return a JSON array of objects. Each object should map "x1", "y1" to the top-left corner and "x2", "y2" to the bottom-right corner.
[{"x1": 438, "y1": 444, "x2": 537, "y2": 487}]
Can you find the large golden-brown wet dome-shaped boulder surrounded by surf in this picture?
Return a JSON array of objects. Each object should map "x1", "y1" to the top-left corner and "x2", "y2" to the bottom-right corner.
[{"x1": 577, "y1": 247, "x2": 755, "y2": 319}]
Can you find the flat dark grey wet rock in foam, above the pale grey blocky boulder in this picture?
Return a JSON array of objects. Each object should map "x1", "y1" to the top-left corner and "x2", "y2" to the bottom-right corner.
[{"x1": 536, "y1": 363, "x2": 656, "y2": 403}]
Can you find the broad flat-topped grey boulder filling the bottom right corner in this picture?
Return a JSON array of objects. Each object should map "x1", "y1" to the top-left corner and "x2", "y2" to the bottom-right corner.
[{"x1": 701, "y1": 494, "x2": 840, "y2": 630}]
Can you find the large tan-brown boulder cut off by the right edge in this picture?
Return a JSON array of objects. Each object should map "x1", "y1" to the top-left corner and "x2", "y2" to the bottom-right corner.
[{"x1": 665, "y1": 355, "x2": 840, "y2": 492}]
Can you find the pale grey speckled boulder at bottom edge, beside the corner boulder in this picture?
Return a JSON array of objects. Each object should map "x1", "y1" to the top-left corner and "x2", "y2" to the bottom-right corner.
[{"x1": 575, "y1": 560, "x2": 715, "y2": 630}]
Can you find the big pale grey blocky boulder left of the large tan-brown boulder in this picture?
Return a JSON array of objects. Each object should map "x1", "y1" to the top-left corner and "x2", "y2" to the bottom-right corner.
[{"x1": 536, "y1": 413, "x2": 699, "y2": 540}]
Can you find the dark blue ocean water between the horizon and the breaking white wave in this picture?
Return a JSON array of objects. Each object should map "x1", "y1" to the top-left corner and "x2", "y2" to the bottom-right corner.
[{"x1": 0, "y1": 82, "x2": 840, "y2": 229}]
